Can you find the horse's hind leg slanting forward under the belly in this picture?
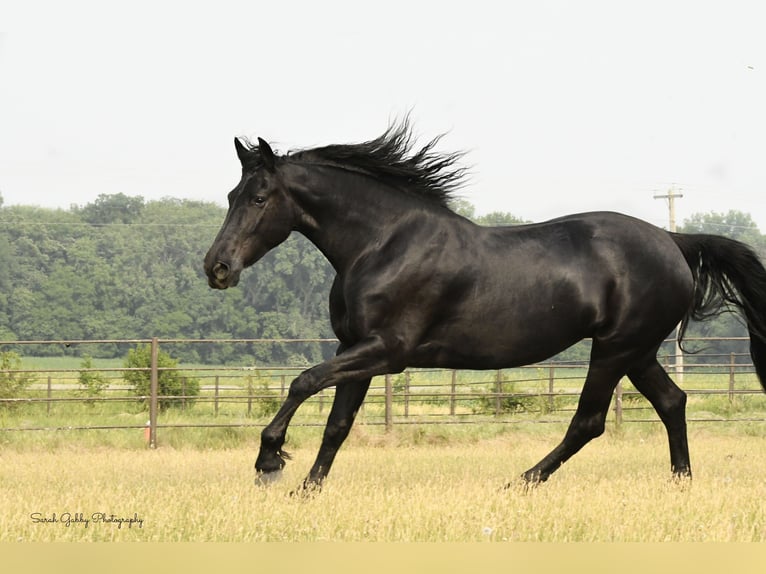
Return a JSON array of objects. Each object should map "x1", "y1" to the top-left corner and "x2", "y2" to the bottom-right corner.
[{"x1": 522, "y1": 356, "x2": 626, "y2": 483}]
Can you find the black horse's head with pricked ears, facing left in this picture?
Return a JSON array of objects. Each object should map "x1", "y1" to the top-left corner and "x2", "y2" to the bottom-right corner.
[{"x1": 205, "y1": 138, "x2": 296, "y2": 289}]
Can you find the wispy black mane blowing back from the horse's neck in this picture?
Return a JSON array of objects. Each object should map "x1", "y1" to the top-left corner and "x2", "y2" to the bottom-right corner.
[{"x1": 243, "y1": 119, "x2": 467, "y2": 206}]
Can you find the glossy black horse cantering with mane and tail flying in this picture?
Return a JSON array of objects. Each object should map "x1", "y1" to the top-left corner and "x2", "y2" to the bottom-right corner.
[{"x1": 205, "y1": 120, "x2": 766, "y2": 487}]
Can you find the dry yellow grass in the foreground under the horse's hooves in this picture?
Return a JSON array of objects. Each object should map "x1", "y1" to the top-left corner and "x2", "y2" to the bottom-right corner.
[{"x1": 0, "y1": 425, "x2": 766, "y2": 542}]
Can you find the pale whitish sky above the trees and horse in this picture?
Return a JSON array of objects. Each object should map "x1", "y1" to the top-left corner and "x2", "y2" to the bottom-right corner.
[{"x1": 0, "y1": 0, "x2": 766, "y2": 232}]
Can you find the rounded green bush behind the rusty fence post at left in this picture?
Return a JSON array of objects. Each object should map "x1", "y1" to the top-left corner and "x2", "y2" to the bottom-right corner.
[{"x1": 123, "y1": 345, "x2": 200, "y2": 411}]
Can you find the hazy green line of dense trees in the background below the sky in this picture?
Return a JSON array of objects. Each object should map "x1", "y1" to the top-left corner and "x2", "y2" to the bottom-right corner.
[{"x1": 0, "y1": 194, "x2": 766, "y2": 364}]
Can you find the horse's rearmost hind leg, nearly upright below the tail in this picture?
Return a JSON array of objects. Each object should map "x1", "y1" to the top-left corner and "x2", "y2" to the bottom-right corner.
[{"x1": 628, "y1": 356, "x2": 692, "y2": 478}]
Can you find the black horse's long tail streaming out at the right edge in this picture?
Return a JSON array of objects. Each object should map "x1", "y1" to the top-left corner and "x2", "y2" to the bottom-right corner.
[{"x1": 671, "y1": 233, "x2": 766, "y2": 391}]
